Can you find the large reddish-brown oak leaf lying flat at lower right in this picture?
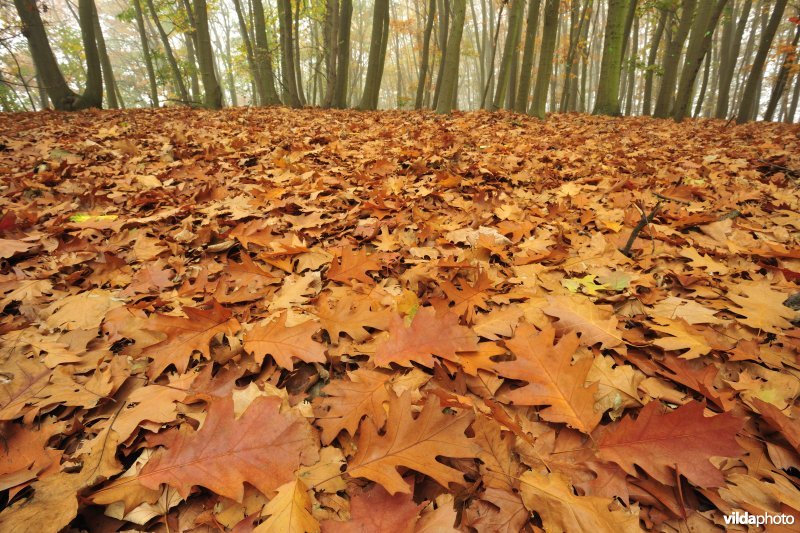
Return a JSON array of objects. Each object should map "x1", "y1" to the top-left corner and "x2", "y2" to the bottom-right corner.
[{"x1": 597, "y1": 401, "x2": 744, "y2": 488}]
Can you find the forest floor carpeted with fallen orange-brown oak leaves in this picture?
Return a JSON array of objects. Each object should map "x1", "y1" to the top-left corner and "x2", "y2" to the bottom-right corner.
[{"x1": 0, "y1": 108, "x2": 800, "y2": 532}]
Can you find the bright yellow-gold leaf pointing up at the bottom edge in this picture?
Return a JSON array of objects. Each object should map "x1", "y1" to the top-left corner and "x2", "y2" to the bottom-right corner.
[{"x1": 253, "y1": 479, "x2": 320, "y2": 533}]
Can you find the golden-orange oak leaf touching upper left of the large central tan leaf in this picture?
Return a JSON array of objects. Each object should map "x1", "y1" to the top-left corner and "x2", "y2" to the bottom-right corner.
[{"x1": 316, "y1": 368, "x2": 391, "y2": 445}]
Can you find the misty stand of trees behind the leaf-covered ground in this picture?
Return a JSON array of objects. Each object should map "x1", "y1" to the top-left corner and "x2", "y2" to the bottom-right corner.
[{"x1": 0, "y1": 0, "x2": 800, "y2": 122}]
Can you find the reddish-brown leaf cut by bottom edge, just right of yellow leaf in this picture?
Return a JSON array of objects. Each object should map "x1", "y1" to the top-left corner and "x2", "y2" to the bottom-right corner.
[{"x1": 322, "y1": 484, "x2": 424, "y2": 533}]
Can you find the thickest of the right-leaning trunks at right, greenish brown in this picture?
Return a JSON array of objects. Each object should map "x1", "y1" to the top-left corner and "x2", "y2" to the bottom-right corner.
[{"x1": 672, "y1": 0, "x2": 728, "y2": 122}]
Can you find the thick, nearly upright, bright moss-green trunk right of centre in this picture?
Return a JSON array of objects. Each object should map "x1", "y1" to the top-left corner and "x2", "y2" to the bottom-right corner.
[{"x1": 594, "y1": 0, "x2": 630, "y2": 116}]
